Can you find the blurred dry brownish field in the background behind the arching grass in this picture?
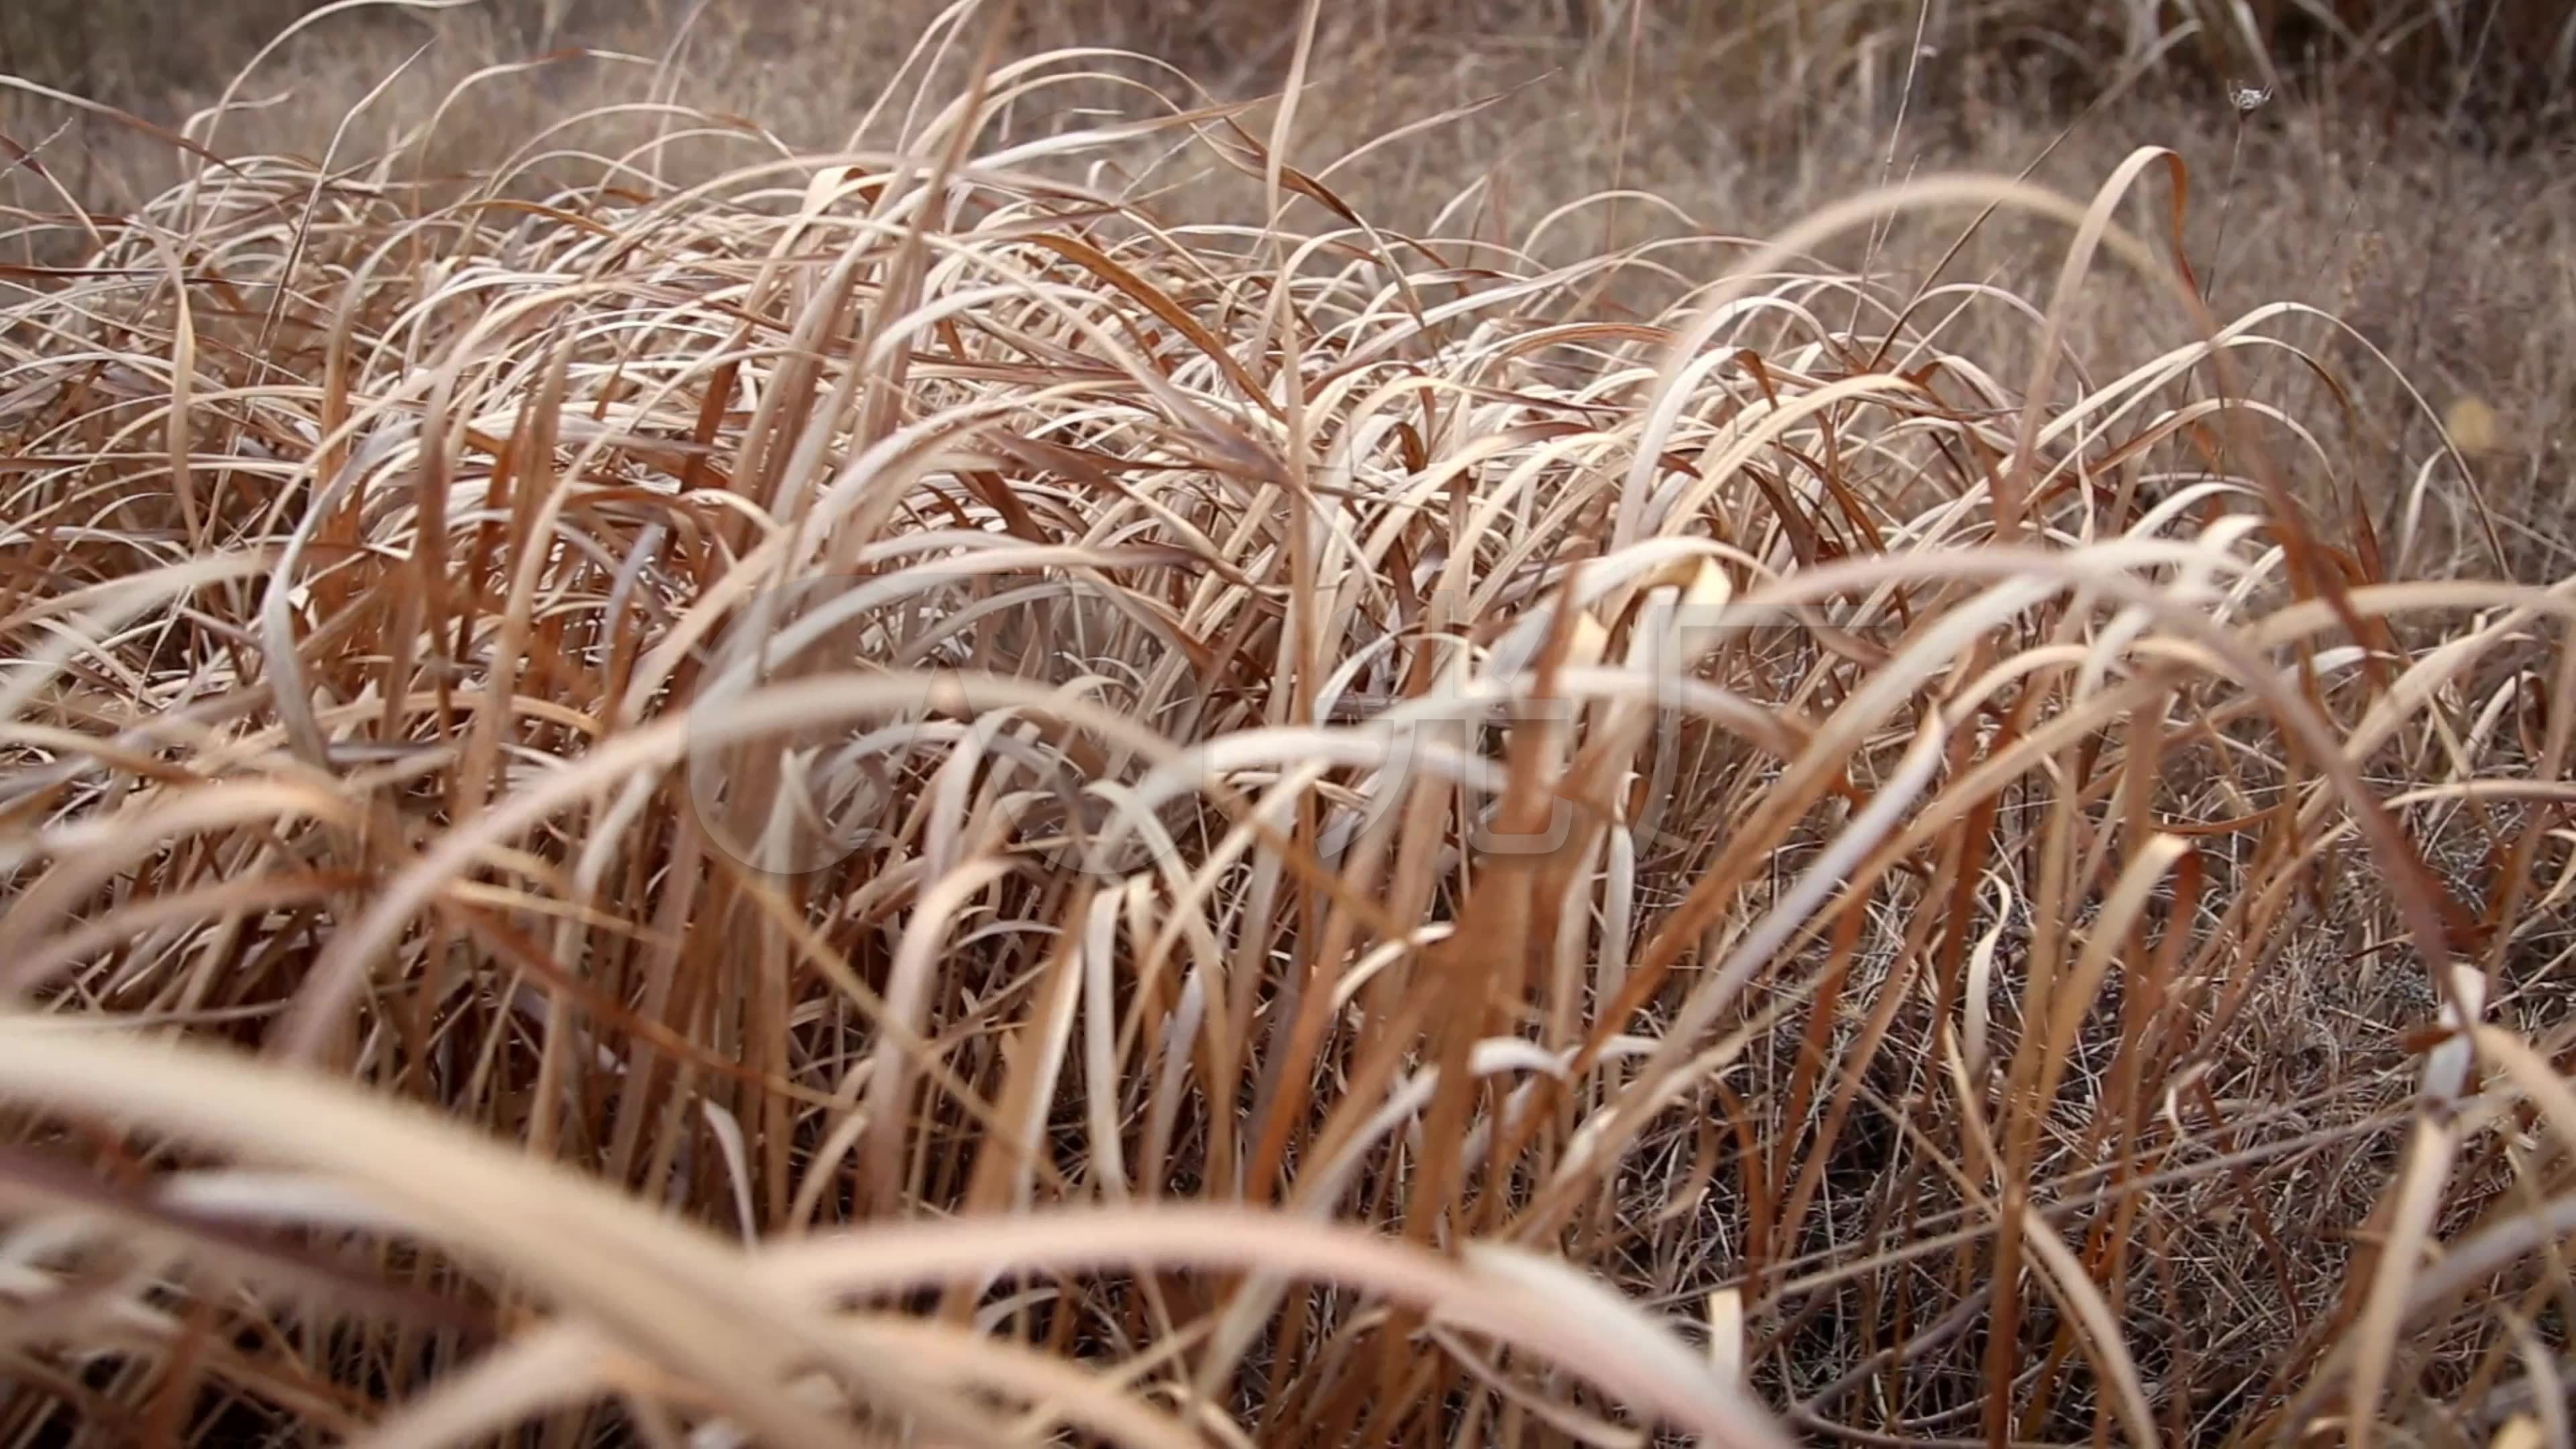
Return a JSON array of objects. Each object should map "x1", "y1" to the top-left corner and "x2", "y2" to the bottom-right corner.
[{"x1": 20, "y1": 0, "x2": 2576, "y2": 572}]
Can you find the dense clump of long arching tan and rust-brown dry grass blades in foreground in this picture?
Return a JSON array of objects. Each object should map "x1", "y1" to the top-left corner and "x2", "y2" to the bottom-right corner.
[{"x1": 0, "y1": 13, "x2": 2576, "y2": 1446}]
